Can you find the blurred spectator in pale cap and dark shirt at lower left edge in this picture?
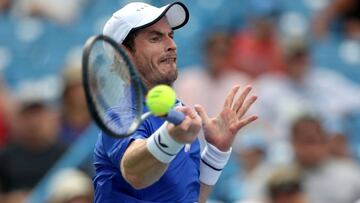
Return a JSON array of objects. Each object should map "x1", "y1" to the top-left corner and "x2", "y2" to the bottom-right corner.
[{"x1": 0, "y1": 81, "x2": 65, "y2": 202}]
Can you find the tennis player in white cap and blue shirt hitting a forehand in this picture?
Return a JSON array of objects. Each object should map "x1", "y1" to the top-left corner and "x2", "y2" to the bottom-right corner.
[{"x1": 94, "y1": 2, "x2": 257, "y2": 203}]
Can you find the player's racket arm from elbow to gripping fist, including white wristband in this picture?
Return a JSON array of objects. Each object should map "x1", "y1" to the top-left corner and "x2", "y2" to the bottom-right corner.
[{"x1": 120, "y1": 107, "x2": 201, "y2": 189}]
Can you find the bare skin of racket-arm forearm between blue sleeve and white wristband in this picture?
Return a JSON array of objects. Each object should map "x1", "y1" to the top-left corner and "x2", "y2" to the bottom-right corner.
[{"x1": 120, "y1": 140, "x2": 168, "y2": 189}]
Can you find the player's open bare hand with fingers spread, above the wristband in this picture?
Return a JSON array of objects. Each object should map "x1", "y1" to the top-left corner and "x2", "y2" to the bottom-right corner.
[{"x1": 195, "y1": 85, "x2": 258, "y2": 152}]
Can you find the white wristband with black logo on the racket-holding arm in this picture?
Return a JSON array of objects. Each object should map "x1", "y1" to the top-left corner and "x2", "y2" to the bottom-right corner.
[{"x1": 146, "y1": 122, "x2": 184, "y2": 164}]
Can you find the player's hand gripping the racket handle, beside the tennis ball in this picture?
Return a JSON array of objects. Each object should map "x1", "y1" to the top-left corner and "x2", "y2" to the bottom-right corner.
[{"x1": 167, "y1": 106, "x2": 201, "y2": 143}]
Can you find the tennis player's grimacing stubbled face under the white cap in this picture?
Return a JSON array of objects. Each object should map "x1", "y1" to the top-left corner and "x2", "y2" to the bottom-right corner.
[{"x1": 130, "y1": 17, "x2": 177, "y2": 88}]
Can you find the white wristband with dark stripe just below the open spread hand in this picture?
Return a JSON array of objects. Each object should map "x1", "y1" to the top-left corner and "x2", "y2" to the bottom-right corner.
[{"x1": 200, "y1": 143, "x2": 232, "y2": 185}]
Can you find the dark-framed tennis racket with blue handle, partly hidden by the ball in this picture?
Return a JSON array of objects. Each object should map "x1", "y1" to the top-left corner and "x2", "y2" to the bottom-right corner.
[{"x1": 82, "y1": 35, "x2": 185, "y2": 138}]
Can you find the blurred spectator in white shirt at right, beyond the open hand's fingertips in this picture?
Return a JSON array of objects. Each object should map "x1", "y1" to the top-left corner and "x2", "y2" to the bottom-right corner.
[{"x1": 254, "y1": 40, "x2": 360, "y2": 144}]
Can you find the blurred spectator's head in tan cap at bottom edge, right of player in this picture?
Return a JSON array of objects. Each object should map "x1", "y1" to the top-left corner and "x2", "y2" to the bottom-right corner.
[{"x1": 266, "y1": 167, "x2": 308, "y2": 203}]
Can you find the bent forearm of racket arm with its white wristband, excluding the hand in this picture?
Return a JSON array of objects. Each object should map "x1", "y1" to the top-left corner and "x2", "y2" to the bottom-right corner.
[{"x1": 120, "y1": 122, "x2": 188, "y2": 189}]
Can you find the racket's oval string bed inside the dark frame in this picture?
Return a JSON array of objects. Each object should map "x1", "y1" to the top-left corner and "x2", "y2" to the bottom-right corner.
[{"x1": 89, "y1": 41, "x2": 139, "y2": 134}]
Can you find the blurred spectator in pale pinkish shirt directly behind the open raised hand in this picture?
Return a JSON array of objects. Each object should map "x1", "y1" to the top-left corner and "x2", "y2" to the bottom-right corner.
[{"x1": 175, "y1": 32, "x2": 248, "y2": 116}]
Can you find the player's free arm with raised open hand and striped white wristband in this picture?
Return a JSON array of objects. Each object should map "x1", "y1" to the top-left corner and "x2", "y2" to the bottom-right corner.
[{"x1": 195, "y1": 86, "x2": 257, "y2": 203}]
